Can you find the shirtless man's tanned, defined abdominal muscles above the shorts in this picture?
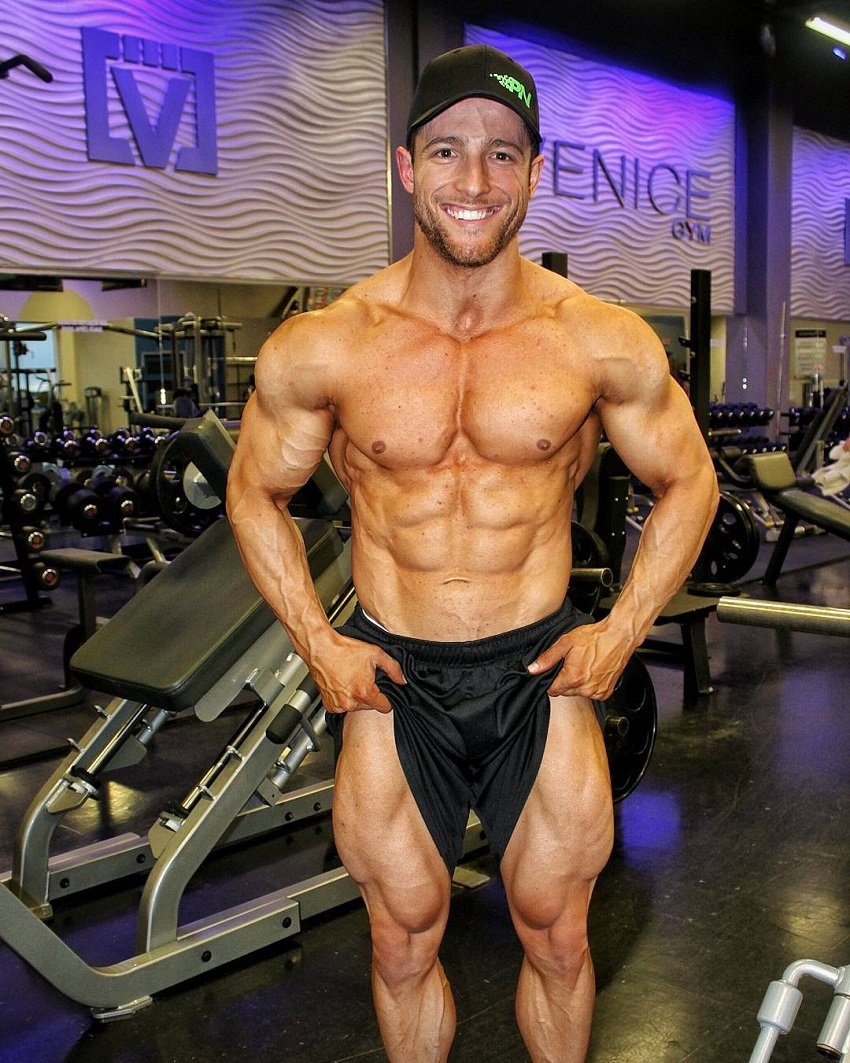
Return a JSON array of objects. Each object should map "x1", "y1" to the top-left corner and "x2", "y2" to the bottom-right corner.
[{"x1": 342, "y1": 467, "x2": 572, "y2": 642}]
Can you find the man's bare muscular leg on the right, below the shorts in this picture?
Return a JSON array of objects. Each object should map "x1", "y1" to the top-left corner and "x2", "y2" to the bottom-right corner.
[{"x1": 502, "y1": 697, "x2": 613, "y2": 1063}]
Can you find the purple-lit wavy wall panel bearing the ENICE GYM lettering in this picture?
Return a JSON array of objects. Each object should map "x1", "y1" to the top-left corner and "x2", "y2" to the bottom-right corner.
[{"x1": 466, "y1": 27, "x2": 735, "y2": 314}]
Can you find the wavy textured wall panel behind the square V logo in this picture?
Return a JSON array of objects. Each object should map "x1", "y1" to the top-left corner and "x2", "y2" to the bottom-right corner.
[{"x1": 0, "y1": 0, "x2": 389, "y2": 284}]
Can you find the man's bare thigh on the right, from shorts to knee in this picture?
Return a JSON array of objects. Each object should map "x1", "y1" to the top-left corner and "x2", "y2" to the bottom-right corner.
[{"x1": 502, "y1": 697, "x2": 613, "y2": 927}]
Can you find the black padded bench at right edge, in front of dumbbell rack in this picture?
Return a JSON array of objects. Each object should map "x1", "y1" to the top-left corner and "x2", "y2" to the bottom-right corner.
[{"x1": 747, "y1": 452, "x2": 850, "y2": 587}]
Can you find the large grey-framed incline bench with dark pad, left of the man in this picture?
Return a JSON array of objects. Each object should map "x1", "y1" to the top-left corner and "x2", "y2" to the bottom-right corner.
[{"x1": 0, "y1": 410, "x2": 357, "y2": 1018}]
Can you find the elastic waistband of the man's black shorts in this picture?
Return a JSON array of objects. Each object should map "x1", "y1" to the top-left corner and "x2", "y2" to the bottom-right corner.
[{"x1": 352, "y1": 598, "x2": 576, "y2": 665}]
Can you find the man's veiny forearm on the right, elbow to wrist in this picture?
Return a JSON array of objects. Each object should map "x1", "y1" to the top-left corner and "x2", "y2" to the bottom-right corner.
[{"x1": 605, "y1": 465, "x2": 718, "y2": 652}]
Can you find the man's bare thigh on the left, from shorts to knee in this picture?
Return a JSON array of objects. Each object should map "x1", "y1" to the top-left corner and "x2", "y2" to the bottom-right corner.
[{"x1": 334, "y1": 710, "x2": 451, "y2": 927}]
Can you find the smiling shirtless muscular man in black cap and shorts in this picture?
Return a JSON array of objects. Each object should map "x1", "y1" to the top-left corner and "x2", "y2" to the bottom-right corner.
[{"x1": 227, "y1": 47, "x2": 717, "y2": 1063}]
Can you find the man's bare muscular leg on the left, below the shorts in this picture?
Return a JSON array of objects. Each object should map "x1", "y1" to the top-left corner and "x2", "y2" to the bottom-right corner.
[{"x1": 334, "y1": 711, "x2": 455, "y2": 1063}]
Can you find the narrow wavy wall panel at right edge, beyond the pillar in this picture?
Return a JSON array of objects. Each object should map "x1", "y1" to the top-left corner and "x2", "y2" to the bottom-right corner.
[{"x1": 791, "y1": 129, "x2": 850, "y2": 321}]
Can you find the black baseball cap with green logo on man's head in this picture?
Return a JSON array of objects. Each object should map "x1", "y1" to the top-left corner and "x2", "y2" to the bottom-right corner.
[{"x1": 407, "y1": 45, "x2": 540, "y2": 148}]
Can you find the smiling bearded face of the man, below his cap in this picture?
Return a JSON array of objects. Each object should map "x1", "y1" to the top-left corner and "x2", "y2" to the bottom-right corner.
[{"x1": 397, "y1": 97, "x2": 543, "y2": 268}]
